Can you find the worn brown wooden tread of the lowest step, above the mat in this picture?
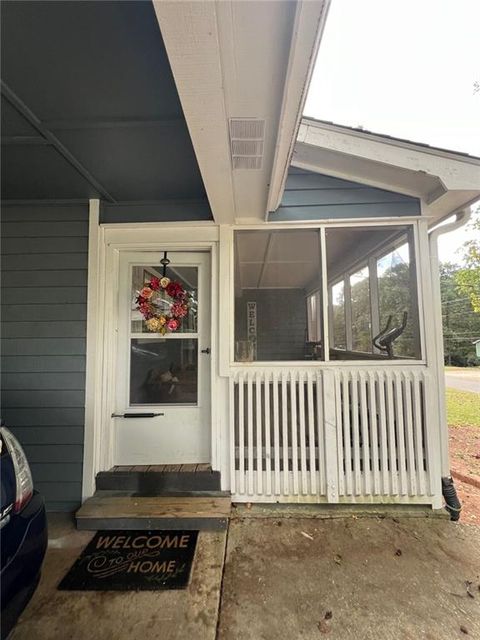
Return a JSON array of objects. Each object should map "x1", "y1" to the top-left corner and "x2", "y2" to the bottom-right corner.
[{"x1": 76, "y1": 496, "x2": 231, "y2": 520}]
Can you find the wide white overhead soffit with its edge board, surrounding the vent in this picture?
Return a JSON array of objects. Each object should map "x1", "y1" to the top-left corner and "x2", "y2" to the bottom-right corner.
[{"x1": 153, "y1": 0, "x2": 330, "y2": 224}]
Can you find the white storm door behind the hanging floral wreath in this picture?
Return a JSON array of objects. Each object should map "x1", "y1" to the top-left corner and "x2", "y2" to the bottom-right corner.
[{"x1": 114, "y1": 251, "x2": 211, "y2": 465}]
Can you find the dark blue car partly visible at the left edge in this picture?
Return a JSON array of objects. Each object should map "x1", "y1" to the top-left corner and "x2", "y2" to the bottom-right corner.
[{"x1": 0, "y1": 427, "x2": 48, "y2": 640}]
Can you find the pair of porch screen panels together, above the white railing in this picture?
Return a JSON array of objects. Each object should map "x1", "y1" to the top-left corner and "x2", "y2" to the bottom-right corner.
[{"x1": 235, "y1": 225, "x2": 421, "y2": 362}]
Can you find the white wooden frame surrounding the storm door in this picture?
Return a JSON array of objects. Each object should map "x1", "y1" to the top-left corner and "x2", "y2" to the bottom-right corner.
[{"x1": 82, "y1": 205, "x2": 224, "y2": 499}]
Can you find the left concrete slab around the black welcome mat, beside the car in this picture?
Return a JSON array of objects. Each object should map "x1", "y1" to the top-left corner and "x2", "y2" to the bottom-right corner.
[{"x1": 9, "y1": 517, "x2": 226, "y2": 640}]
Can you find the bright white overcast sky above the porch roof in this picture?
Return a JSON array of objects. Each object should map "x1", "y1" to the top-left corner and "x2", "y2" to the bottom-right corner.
[{"x1": 304, "y1": 0, "x2": 480, "y2": 262}]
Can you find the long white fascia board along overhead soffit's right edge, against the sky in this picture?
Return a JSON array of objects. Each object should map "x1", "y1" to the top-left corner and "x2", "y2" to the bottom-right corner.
[{"x1": 266, "y1": 0, "x2": 330, "y2": 216}]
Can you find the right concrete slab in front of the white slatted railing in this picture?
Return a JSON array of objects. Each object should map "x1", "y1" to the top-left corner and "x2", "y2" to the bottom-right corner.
[{"x1": 218, "y1": 518, "x2": 480, "y2": 640}]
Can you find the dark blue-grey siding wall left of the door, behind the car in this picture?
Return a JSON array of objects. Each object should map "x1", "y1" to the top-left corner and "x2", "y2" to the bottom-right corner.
[{"x1": 1, "y1": 204, "x2": 88, "y2": 511}]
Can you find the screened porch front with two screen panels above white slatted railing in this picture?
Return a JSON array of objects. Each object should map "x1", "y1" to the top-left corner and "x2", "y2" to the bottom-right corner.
[{"x1": 230, "y1": 223, "x2": 440, "y2": 504}]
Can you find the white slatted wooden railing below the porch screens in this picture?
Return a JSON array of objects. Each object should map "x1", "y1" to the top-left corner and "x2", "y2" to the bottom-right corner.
[{"x1": 230, "y1": 365, "x2": 440, "y2": 503}]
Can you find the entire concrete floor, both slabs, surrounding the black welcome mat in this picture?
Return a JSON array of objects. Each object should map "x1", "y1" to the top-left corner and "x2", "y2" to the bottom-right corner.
[{"x1": 11, "y1": 508, "x2": 480, "y2": 640}]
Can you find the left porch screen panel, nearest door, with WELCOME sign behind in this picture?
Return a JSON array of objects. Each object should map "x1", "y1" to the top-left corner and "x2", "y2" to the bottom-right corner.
[{"x1": 235, "y1": 229, "x2": 322, "y2": 361}]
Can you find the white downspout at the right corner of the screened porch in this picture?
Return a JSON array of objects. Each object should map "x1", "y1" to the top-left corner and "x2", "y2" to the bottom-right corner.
[{"x1": 428, "y1": 208, "x2": 472, "y2": 478}]
